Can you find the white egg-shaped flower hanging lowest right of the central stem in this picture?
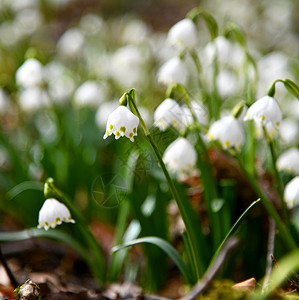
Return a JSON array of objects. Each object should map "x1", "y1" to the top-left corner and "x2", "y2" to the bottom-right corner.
[{"x1": 163, "y1": 138, "x2": 197, "y2": 174}]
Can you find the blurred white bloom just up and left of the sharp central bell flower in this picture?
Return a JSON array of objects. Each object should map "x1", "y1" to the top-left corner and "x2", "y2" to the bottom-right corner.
[{"x1": 74, "y1": 81, "x2": 105, "y2": 107}]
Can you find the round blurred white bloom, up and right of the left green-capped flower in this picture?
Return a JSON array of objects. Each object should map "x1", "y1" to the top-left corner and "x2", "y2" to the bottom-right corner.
[{"x1": 57, "y1": 28, "x2": 84, "y2": 58}]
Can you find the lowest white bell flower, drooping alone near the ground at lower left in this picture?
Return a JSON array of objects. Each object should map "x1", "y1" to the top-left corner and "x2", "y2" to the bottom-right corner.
[{"x1": 37, "y1": 198, "x2": 75, "y2": 230}]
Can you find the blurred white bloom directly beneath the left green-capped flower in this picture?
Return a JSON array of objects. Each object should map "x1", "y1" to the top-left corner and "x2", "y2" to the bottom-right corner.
[{"x1": 18, "y1": 87, "x2": 51, "y2": 113}]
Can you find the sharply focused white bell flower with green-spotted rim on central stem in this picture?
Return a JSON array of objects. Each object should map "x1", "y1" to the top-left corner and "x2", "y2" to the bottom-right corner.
[{"x1": 104, "y1": 105, "x2": 139, "y2": 142}]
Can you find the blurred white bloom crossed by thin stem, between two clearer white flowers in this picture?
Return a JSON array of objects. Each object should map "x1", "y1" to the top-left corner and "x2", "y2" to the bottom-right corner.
[{"x1": 182, "y1": 100, "x2": 209, "y2": 126}]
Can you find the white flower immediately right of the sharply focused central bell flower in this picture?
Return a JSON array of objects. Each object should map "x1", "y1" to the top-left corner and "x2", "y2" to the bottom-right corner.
[{"x1": 154, "y1": 98, "x2": 184, "y2": 131}]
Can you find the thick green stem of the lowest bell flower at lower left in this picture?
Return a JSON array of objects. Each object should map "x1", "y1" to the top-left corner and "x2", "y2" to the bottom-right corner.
[{"x1": 45, "y1": 178, "x2": 105, "y2": 284}]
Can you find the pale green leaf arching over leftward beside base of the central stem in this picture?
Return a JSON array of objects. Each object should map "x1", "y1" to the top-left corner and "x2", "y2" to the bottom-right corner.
[{"x1": 111, "y1": 236, "x2": 193, "y2": 283}]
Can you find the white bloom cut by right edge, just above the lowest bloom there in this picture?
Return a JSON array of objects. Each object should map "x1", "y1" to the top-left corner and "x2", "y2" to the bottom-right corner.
[{"x1": 276, "y1": 148, "x2": 299, "y2": 175}]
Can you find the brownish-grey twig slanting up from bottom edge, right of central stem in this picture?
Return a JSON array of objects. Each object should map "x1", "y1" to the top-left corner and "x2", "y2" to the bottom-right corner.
[{"x1": 179, "y1": 237, "x2": 238, "y2": 300}]
